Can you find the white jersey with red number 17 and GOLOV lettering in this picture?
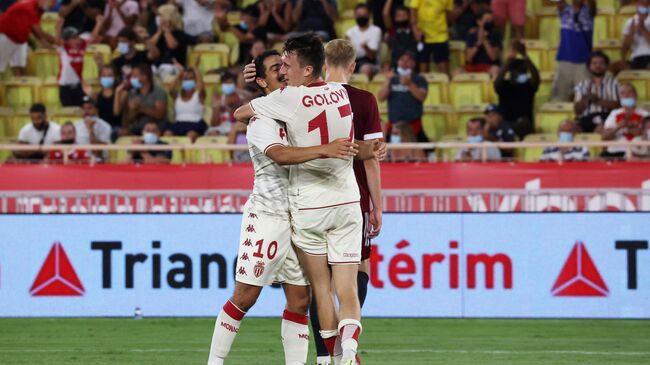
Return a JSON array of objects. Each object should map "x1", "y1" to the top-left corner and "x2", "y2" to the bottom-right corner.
[{"x1": 250, "y1": 82, "x2": 359, "y2": 209}]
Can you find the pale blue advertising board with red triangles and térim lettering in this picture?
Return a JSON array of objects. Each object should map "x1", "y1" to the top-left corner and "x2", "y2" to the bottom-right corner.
[{"x1": 0, "y1": 213, "x2": 650, "y2": 318}]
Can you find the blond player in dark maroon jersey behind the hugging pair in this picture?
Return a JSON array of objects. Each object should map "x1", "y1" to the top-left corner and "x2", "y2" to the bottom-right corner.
[{"x1": 309, "y1": 39, "x2": 384, "y2": 365}]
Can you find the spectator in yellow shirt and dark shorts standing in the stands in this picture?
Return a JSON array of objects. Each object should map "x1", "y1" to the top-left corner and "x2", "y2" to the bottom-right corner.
[{"x1": 409, "y1": 0, "x2": 460, "y2": 74}]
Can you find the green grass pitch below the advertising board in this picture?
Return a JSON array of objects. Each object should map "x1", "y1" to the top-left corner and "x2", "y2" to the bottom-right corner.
[{"x1": 0, "y1": 318, "x2": 650, "y2": 365}]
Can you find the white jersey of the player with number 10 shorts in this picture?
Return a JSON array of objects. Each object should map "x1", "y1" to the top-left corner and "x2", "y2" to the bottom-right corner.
[{"x1": 246, "y1": 116, "x2": 289, "y2": 219}]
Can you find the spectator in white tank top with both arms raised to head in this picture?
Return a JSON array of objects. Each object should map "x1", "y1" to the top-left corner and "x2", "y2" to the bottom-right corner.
[{"x1": 166, "y1": 60, "x2": 208, "y2": 143}]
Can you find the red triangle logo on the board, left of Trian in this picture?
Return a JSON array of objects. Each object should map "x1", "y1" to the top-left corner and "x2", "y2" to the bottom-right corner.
[{"x1": 29, "y1": 242, "x2": 85, "y2": 296}]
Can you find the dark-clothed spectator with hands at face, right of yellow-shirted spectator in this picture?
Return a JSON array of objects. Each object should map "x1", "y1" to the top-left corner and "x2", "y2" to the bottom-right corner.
[{"x1": 456, "y1": 10, "x2": 503, "y2": 78}]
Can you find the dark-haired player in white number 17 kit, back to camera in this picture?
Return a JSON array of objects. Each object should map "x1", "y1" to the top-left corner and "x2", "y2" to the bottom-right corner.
[{"x1": 235, "y1": 34, "x2": 362, "y2": 365}]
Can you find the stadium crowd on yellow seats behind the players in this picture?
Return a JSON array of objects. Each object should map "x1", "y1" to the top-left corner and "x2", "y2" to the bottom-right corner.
[{"x1": 0, "y1": 0, "x2": 650, "y2": 163}]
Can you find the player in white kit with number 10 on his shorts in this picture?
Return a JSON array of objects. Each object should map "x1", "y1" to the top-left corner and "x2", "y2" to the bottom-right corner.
[{"x1": 208, "y1": 51, "x2": 360, "y2": 365}]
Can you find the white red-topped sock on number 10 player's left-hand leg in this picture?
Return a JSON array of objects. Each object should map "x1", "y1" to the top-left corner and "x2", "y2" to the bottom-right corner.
[{"x1": 208, "y1": 301, "x2": 246, "y2": 365}]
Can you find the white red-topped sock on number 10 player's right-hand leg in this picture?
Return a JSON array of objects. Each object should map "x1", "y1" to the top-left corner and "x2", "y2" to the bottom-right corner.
[{"x1": 282, "y1": 309, "x2": 309, "y2": 365}]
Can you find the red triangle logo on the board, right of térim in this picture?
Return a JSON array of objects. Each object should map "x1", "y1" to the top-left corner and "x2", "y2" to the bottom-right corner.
[{"x1": 551, "y1": 241, "x2": 609, "y2": 297}]
